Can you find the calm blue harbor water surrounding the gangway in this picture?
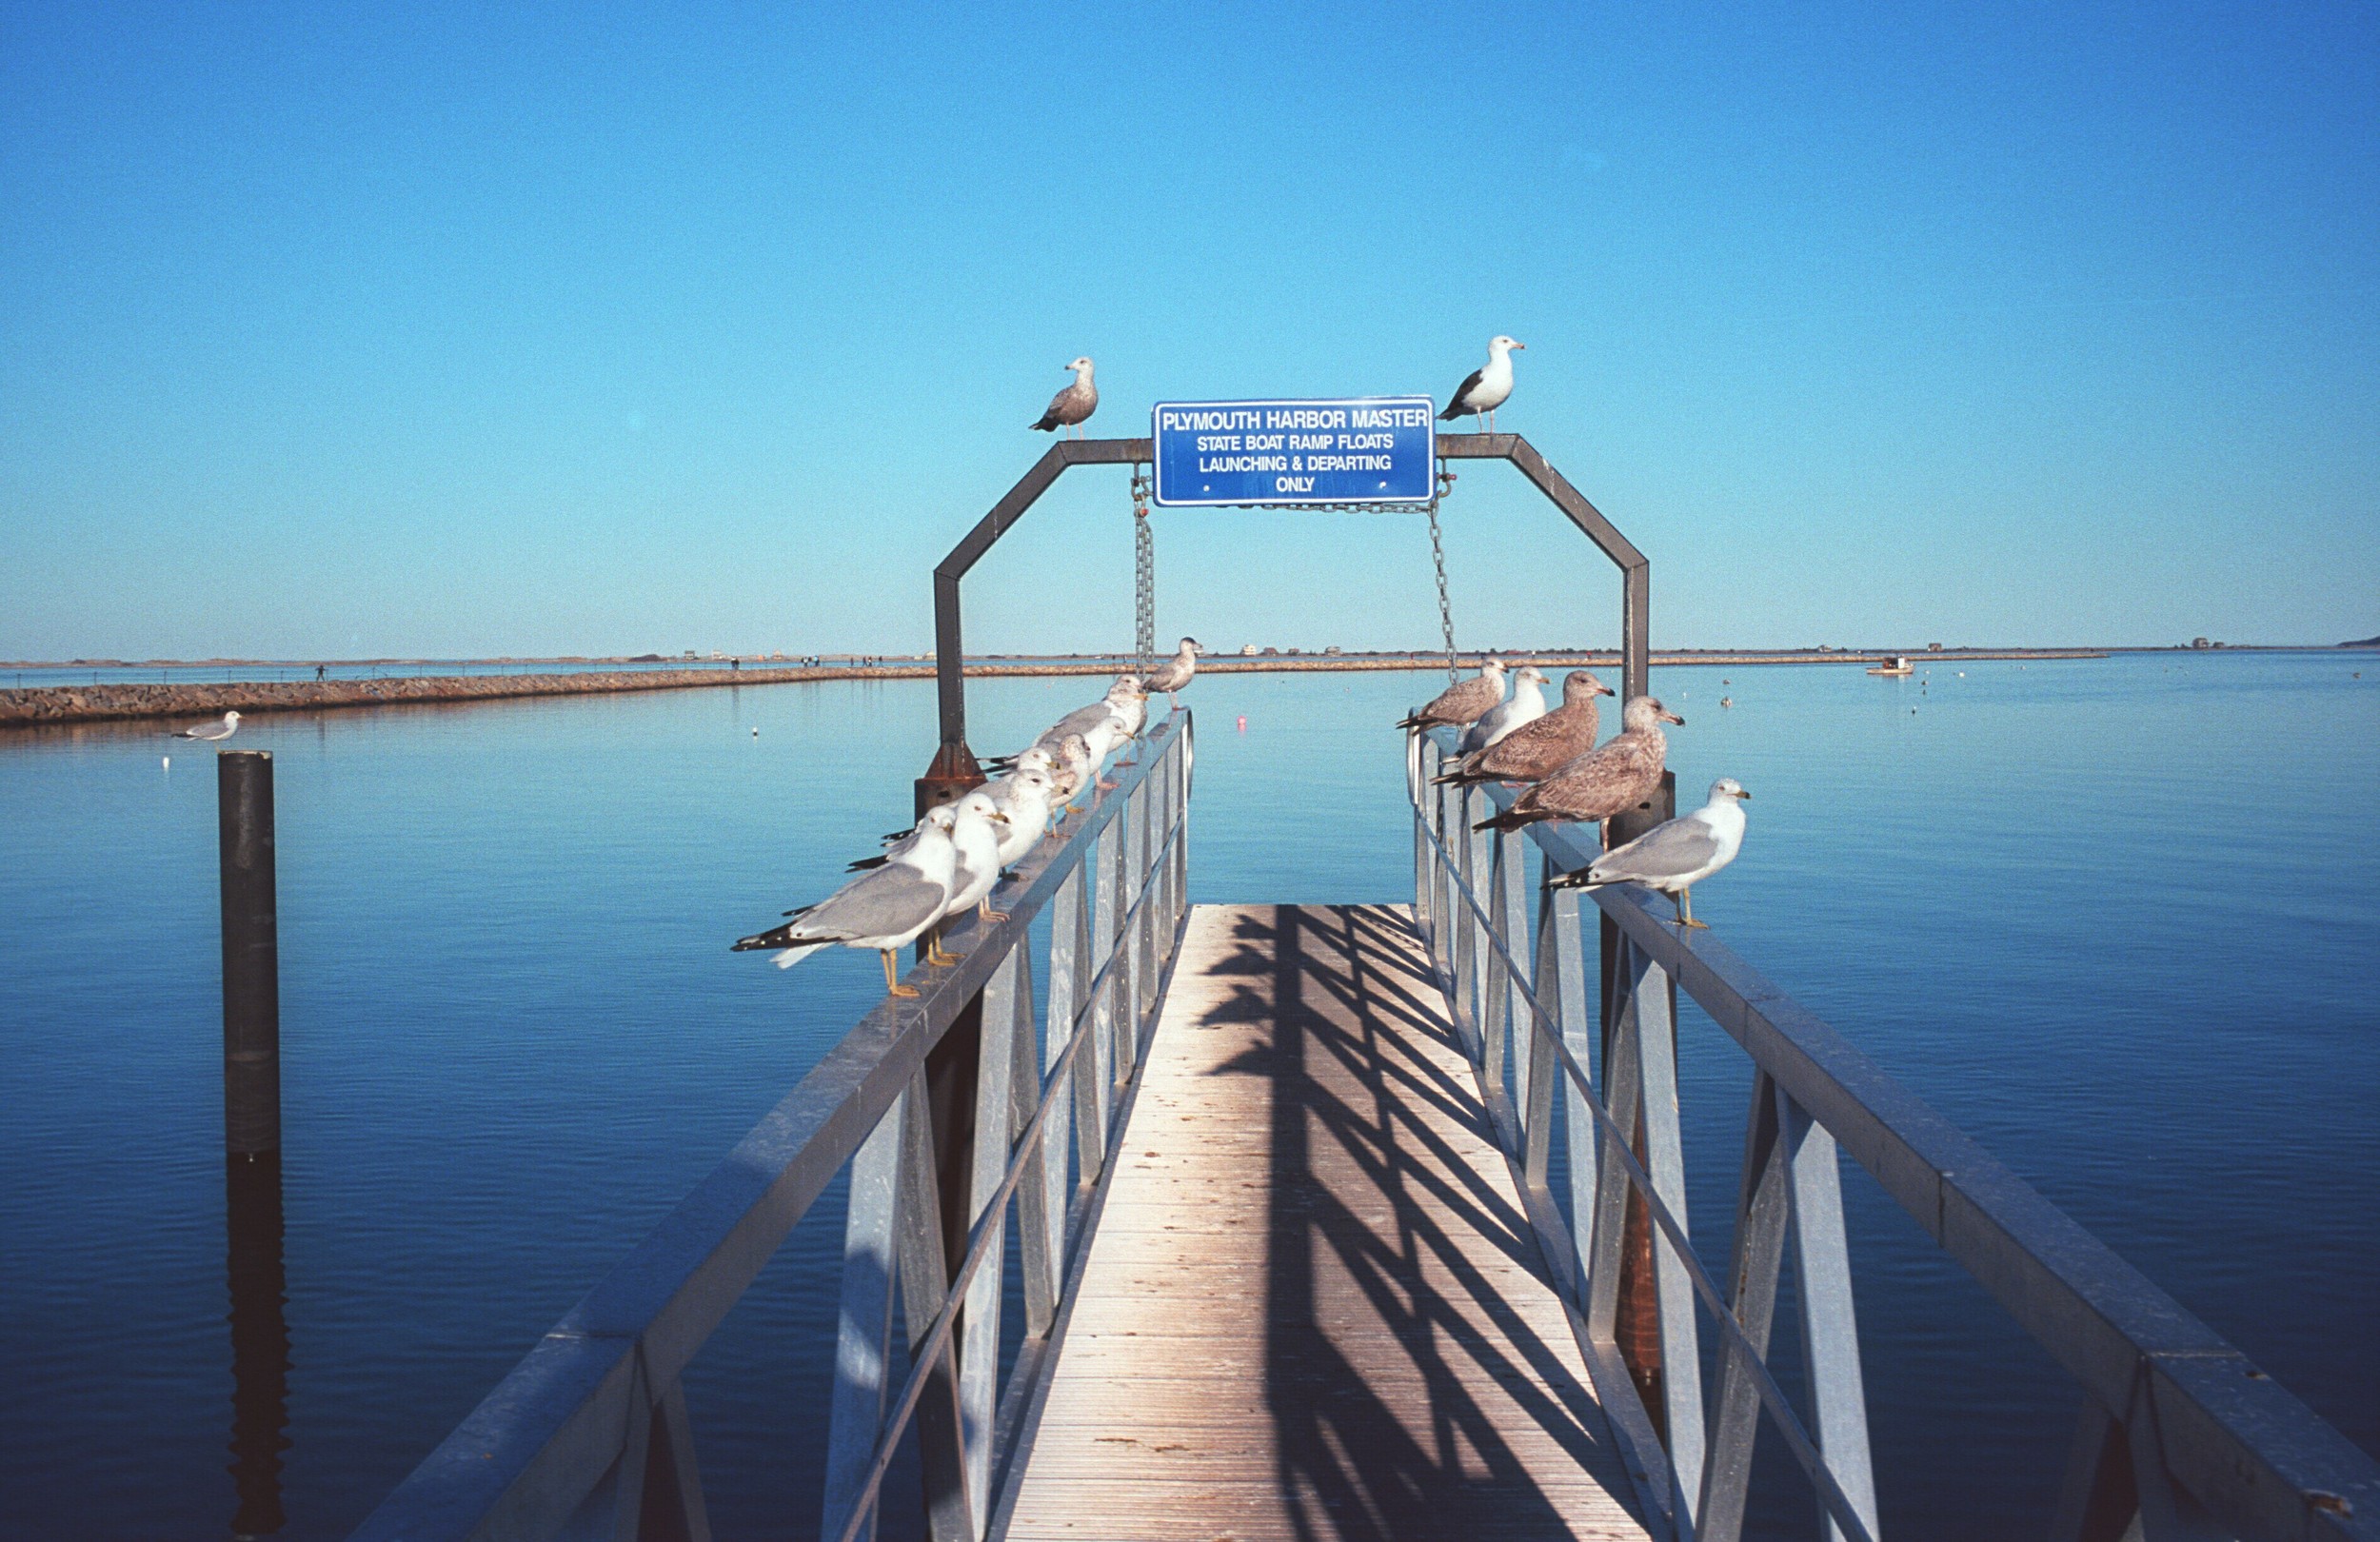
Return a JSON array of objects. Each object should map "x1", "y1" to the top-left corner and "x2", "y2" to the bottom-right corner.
[{"x1": 0, "y1": 655, "x2": 2380, "y2": 1540}]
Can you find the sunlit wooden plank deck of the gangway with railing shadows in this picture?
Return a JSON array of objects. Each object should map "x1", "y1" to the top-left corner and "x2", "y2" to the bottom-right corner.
[{"x1": 1002, "y1": 904, "x2": 1645, "y2": 1542}]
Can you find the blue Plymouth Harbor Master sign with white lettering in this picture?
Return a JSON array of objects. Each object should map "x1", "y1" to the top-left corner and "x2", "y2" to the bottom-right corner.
[{"x1": 1155, "y1": 398, "x2": 1438, "y2": 507}]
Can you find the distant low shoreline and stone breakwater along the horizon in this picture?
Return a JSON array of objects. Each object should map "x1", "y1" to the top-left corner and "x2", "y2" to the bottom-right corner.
[{"x1": 0, "y1": 647, "x2": 2332, "y2": 728}]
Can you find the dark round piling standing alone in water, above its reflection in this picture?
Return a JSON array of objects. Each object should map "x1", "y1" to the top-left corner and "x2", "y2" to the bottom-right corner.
[{"x1": 214, "y1": 750, "x2": 281, "y2": 1156}]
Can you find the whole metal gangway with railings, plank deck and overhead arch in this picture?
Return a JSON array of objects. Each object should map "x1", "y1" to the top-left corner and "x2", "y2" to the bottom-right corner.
[{"x1": 355, "y1": 436, "x2": 2380, "y2": 1542}]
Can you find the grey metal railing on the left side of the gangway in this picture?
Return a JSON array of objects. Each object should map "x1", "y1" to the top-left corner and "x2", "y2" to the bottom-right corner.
[{"x1": 355, "y1": 709, "x2": 1209, "y2": 1542}]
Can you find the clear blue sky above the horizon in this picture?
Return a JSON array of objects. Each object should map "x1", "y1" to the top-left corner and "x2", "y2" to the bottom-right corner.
[{"x1": 0, "y1": 0, "x2": 2380, "y2": 657}]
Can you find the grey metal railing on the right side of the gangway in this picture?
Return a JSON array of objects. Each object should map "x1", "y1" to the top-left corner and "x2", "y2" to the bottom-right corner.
[{"x1": 1407, "y1": 731, "x2": 2380, "y2": 1542}]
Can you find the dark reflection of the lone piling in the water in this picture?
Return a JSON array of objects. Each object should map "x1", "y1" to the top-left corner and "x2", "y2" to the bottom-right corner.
[{"x1": 224, "y1": 1152, "x2": 290, "y2": 1537}]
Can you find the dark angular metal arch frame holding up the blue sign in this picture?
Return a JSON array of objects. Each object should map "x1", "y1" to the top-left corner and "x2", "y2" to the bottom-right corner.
[{"x1": 919, "y1": 433, "x2": 1652, "y2": 795}]
